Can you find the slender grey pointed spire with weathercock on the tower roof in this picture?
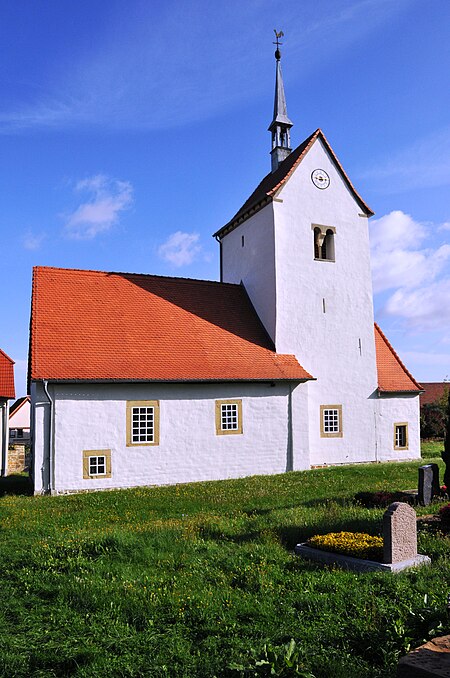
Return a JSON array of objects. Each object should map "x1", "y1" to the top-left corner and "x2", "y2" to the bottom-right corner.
[{"x1": 269, "y1": 30, "x2": 293, "y2": 172}]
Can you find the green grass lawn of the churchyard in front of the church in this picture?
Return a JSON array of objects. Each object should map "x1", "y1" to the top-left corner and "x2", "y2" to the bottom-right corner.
[{"x1": 0, "y1": 454, "x2": 450, "y2": 678}]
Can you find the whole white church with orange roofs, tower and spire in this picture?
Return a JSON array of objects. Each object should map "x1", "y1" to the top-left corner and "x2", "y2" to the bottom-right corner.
[{"x1": 29, "y1": 49, "x2": 421, "y2": 493}]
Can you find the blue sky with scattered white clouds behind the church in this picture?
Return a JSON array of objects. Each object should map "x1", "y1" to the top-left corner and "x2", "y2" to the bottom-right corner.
[{"x1": 0, "y1": 0, "x2": 450, "y2": 395}]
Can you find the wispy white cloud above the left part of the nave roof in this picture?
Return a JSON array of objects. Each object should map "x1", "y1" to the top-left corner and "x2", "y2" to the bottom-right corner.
[{"x1": 64, "y1": 174, "x2": 133, "y2": 240}]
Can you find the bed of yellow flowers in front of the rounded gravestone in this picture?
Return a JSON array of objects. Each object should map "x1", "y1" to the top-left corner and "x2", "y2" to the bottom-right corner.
[{"x1": 306, "y1": 532, "x2": 383, "y2": 562}]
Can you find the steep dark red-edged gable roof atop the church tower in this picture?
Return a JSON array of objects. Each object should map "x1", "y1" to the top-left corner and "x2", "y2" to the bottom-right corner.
[{"x1": 214, "y1": 129, "x2": 374, "y2": 237}]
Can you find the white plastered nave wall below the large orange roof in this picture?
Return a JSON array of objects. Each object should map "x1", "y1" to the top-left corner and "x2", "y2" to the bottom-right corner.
[{"x1": 33, "y1": 382, "x2": 309, "y2": 492}]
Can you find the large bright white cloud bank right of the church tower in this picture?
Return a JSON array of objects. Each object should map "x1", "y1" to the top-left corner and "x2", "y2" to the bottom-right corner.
[{"x1": 371, "y1": 210, "x2": 450, "y2": 330}]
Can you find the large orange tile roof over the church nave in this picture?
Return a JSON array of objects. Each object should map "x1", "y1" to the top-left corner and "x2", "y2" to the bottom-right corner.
[{"x1": 29, "y1": 267, "x2": 312, "y2": 381}]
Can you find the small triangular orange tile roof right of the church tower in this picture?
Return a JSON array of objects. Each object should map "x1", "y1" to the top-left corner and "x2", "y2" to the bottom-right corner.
[{"x1": 375, "y1": 323, "x2": 422, "y2": 393}]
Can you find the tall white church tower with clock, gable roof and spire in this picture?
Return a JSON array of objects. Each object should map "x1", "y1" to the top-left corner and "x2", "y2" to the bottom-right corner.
[{"x1": 215, "y1": 34, "x2": 386, "y2": 465}]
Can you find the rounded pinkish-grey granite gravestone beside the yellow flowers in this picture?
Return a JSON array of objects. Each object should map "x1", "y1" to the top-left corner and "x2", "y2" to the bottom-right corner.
[{"x1": 383, "y1": 501, "x2": 417, "y2": 563}]
